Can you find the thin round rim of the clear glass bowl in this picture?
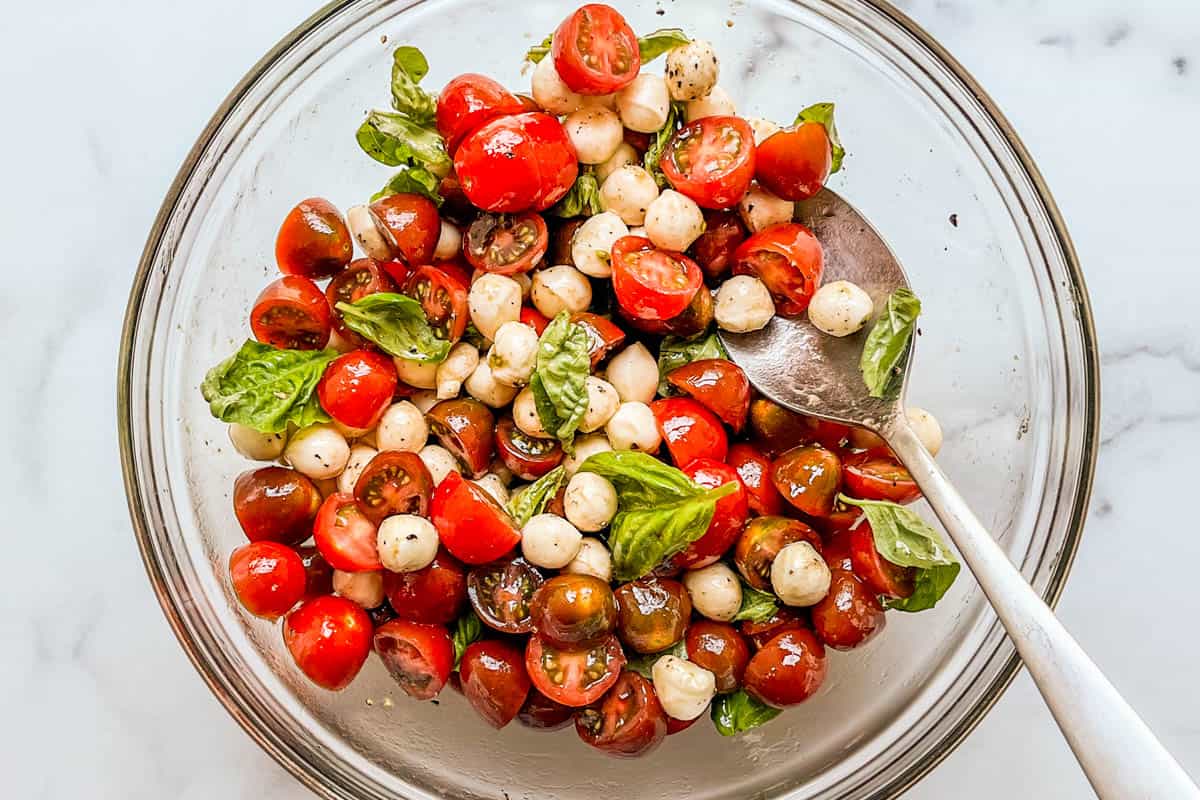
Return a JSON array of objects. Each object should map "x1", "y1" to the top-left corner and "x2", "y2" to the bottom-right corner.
[{"x1": 116, "y1": 0, "x2": 1100, "y2": 800}]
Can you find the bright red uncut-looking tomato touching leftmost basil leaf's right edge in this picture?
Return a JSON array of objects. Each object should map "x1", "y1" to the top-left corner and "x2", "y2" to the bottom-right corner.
[{"x1": 317, "y1": 350, "x2": 400, "y2": 428}]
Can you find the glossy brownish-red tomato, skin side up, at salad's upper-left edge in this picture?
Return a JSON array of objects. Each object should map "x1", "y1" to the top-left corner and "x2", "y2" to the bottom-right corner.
[{"x1": 275, "y1": 197, "x2": 354, "y2": 279}]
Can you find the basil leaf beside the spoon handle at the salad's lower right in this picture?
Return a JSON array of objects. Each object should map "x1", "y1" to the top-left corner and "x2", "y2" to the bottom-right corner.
[{"x1": 838, "y1": 494, "x2": 962, "y2": 612}]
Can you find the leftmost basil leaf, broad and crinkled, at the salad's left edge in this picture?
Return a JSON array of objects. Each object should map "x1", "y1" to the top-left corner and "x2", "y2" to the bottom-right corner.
[{"x1": 200, "y1": 339, "x2": 338, "y2": 433}]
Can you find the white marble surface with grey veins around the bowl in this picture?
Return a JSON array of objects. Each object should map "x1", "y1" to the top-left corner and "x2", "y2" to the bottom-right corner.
[{"x1": 0, "y1": 0, "x2": 1200, "y2": 800}]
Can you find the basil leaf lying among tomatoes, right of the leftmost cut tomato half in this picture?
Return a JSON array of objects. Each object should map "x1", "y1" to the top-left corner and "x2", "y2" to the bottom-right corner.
[{"x1": 337, "y1": 291, "x2": 450, "y2": 363}]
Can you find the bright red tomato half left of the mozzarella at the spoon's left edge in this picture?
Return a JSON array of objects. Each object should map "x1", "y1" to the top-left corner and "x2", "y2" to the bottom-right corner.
[{"x1": 612, "y1": 236, "x2": 704, "y2": 320}]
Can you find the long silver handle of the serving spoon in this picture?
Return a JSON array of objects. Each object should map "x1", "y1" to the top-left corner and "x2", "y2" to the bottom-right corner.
[{"x1": 884, "y1": 415, "x2": 1200, "y2": 800}]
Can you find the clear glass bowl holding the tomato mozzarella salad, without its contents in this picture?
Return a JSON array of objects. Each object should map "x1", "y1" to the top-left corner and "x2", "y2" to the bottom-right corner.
[{"x1": 119, "y1": 0, "x2": 1099, "y2": 800}]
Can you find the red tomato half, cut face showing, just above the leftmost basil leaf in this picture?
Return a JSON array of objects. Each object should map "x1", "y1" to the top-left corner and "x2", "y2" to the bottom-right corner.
[{"x1": 250, "y1": 275, "x2": 332, "y2": 350}]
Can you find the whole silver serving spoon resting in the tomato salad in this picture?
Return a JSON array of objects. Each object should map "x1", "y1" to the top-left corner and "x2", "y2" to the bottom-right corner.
[{"x1": 721, "y1": 190, "x2": 1200, "y2": 800}]
